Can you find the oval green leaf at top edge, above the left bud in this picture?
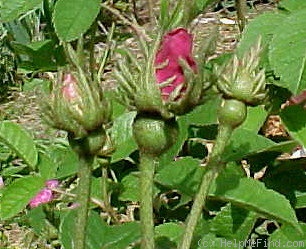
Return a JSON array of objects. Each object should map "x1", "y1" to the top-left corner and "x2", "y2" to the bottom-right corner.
[{"x1": 53, "y1": 0, "x2": 101, "y2": 42}]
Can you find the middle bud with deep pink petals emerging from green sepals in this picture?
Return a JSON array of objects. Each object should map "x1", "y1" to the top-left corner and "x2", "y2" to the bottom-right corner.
[{"x1": 114, "y1": 28, "x2": 211, "y2": 119}]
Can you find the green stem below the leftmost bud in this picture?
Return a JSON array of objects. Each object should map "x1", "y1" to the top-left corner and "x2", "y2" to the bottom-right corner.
[{"x1": 74, "y1": 155, "x2": 93, "y2": 249}]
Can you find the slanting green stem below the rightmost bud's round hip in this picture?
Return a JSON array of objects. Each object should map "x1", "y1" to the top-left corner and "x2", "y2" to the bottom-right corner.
[{"x1": 178, "y1": 125, "x2": 233, "y2": 249}]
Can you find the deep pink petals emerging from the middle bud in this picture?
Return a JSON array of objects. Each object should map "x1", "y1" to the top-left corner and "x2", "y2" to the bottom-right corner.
[{"x1": 155, "y1": 28, "x2": 197, "y2": 100}]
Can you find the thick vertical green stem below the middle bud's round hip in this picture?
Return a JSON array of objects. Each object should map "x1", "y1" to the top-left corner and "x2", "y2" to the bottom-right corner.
[{"x1": 139, "y1": 153, "x2": 158, "y2": 249}]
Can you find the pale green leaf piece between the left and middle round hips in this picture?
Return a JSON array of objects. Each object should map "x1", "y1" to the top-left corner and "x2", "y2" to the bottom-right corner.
[{"x1": 111, "y1": 112, "x2": 137, "y2": 162}]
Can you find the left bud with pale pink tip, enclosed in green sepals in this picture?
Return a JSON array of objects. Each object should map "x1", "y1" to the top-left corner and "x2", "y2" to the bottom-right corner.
[{"x1": 43, "y1": 73, "x2": 110, "y2": 138}]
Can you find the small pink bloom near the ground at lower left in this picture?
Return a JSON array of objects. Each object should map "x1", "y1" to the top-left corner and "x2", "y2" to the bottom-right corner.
[{"x1": 29, "y1": 180, "x2": 59, "y2": 208}]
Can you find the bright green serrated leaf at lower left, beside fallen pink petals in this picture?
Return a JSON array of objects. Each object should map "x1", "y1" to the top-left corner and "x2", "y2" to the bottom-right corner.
[{"x1": 0, "y1": 176, "x2": 44, "y2": 219}]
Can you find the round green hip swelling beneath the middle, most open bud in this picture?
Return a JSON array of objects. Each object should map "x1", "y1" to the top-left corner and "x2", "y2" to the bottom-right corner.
[{"x1": 133, "y1": 116, "x2": 178, "y2": 156}]
